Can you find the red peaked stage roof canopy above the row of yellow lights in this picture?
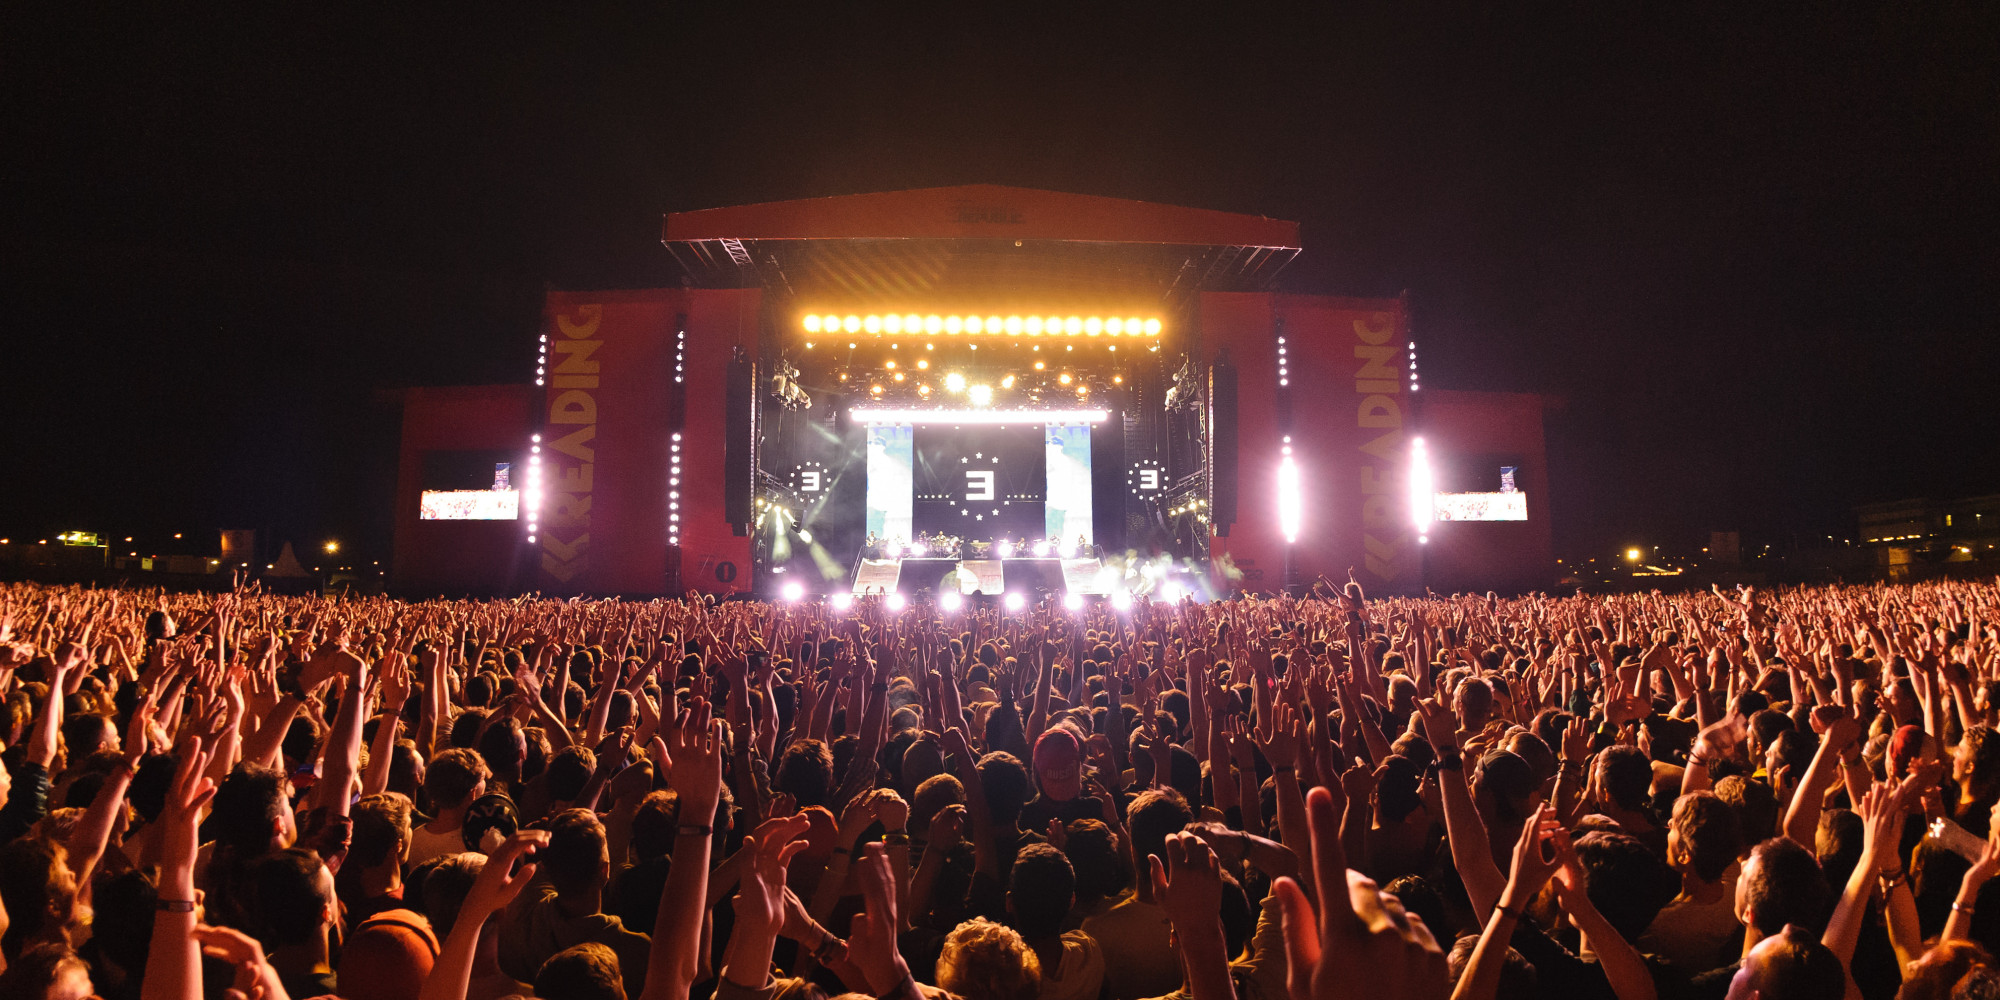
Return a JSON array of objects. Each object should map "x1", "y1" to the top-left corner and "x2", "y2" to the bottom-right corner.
[{"x1": 662, "y1": 184, "x2": 1300, "y2": 306}]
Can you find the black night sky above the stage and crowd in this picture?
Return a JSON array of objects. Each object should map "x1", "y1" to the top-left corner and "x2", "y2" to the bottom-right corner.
[{"x1": 0, "y1": 2, "x2": 2000, "y2": 554}]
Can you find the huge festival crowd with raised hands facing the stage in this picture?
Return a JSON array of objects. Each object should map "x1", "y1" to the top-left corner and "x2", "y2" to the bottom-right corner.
[{"x1": 0, "y1": 580, "x2": 2000, "y2": 1000}]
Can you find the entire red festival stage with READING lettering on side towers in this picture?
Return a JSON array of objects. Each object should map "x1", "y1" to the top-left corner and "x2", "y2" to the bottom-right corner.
[{"x1": 392, "y1": 186, "x2": 1554, "y2": 600}]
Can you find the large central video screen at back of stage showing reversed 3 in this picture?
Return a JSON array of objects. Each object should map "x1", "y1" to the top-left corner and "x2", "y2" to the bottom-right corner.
[{"x1": 868, "y1": 422, "x2": 1094, "y2": 542}]
